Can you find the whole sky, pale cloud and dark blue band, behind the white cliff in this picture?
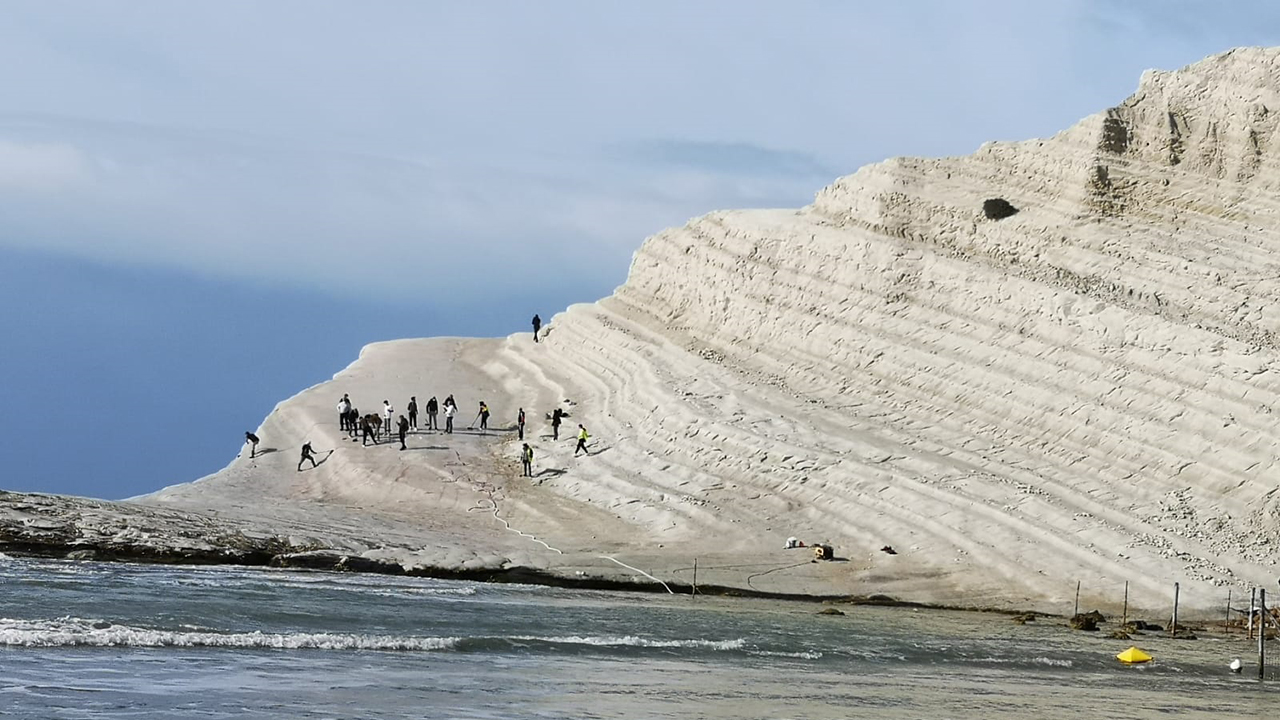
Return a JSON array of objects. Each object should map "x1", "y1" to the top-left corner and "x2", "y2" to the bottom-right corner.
[{"x1": 0, "y1": 0, "x2": 1280, "y2": 498}]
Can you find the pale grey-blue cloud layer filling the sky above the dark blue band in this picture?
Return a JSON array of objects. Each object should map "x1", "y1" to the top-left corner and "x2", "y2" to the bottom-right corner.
[{"x1": 0, "y1": 0, "x2": 1259, "y2": 300}]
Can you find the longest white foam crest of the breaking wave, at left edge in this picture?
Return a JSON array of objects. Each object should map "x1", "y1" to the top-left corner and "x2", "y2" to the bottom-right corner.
[{"x1": 0, "y1": 618, "x2": 460, "y2": 651}]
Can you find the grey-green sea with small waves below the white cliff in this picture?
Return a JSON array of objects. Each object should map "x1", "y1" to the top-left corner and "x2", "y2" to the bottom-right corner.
[{"x1": 0, "y1": 556, "x2": 1280, "y2": 720}]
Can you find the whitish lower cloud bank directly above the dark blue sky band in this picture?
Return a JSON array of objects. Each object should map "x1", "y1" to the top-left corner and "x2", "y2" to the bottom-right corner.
[{"x1": 0, "y1": 118, "x2": 817, "y2": 300}]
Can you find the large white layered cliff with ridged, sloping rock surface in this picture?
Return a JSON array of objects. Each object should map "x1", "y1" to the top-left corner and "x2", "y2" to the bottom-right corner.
[{"x1": 12, "y1": 49, "x2": 1280, "y2": 612}]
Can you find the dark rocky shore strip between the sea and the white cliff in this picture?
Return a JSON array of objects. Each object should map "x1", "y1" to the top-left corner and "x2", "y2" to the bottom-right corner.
[{"x1": 0, "y1": 491, "x2": 1233, "y2": 621}]
